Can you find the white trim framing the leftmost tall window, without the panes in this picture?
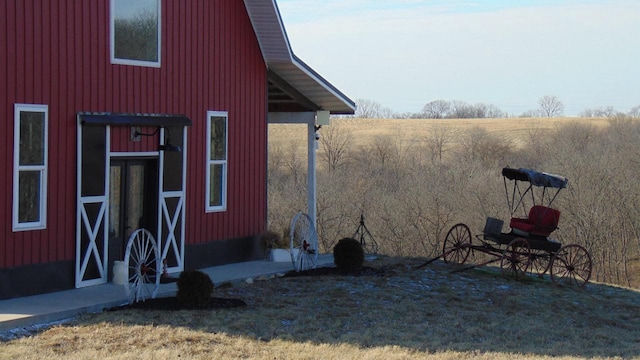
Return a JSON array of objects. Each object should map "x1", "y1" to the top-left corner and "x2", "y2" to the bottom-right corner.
[{"x1": 12, "y1": 104, "x2": 49, "y2": 232}]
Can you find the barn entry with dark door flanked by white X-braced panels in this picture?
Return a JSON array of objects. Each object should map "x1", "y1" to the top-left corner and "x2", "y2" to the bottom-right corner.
[{"x1": 75, "y1": 113, "x2": 191, "y2": 287}]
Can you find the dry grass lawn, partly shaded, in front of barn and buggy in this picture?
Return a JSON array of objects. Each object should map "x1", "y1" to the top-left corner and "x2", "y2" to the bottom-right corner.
[{"x1": 0, "y1": 257, "x2": 640, "y2": 360}]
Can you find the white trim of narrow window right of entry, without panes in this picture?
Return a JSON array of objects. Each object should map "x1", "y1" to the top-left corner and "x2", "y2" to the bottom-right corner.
[{"x1": 205, "y1": 111, "x2": 229, "y2": 212}]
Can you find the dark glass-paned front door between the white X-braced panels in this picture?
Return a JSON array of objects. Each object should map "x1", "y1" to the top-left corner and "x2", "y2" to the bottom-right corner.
[{"x1": 107, "y1": 158, "x2": 158, "y2": 281}]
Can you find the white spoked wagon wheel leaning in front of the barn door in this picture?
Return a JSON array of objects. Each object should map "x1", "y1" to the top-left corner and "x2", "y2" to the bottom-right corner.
[{"x1": 124, "y1": 229, "x2": 162, "y2": 303}]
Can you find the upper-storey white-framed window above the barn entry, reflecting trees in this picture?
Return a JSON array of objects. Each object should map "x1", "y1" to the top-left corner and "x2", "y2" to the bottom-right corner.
[{"x1": 111, "y1": 0, "x2": 161, "y2": 67}]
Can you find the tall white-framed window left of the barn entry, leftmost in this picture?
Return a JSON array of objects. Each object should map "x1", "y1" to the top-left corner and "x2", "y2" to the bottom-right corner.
[{"x1": 12, "y1": 104, "x2": 49, "y2": 231}]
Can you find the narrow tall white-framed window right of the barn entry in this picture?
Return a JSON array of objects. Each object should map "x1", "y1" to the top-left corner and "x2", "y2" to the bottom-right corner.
[{"x1": 206, "y1": 111, "x2": 229, "y2": 212}]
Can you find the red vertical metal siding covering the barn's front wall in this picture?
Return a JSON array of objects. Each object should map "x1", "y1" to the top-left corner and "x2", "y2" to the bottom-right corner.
[{"x1": 0, "y1": 0, "x2": 266, "y2": 268}]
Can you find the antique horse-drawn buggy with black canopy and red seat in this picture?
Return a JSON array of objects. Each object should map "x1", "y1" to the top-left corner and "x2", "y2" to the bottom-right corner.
[{"x1": 441, "y1": 167, "x2": 591, "y2": 287}]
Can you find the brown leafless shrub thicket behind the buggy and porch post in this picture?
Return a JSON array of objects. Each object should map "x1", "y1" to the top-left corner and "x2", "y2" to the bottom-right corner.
[{"x1": 268, "y1": 116, "x2": 640, "y2": 286}]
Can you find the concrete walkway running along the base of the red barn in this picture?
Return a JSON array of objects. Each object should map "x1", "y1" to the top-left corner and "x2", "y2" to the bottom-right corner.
[{"x1": 0, "y1": 254, "x2": 333, "y2": 331}]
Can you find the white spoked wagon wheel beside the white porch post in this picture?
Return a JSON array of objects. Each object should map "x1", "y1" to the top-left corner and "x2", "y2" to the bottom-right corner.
[{"x1": 289, "y1": 212, "x2": 318, "y2": 271}]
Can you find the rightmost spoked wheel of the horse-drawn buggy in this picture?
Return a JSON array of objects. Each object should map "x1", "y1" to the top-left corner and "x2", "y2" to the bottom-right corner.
[{"x1": 551, "y1": 244, "x2": 591, "y2": 287}]
